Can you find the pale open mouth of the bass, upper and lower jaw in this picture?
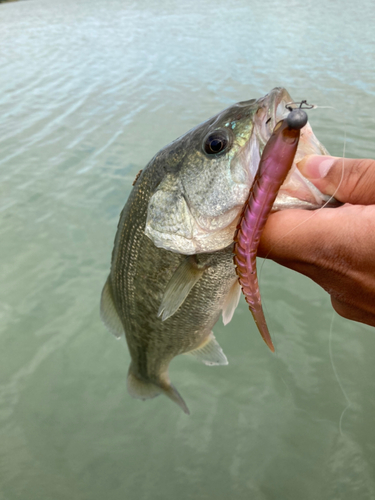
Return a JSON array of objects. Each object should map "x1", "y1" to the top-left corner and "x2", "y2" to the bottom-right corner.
[{"x1": 250, "y1": 87, "x2": 337, "y2": 211}]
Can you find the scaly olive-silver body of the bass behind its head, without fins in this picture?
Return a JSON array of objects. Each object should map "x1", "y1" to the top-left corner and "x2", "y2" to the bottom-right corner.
[{"x1": 110, "y1": 155, "x2": 236, "y2": 381}]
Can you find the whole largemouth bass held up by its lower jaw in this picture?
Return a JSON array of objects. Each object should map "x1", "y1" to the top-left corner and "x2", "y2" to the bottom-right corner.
[{"x1": 101, "y1": 88, "x2": 334, "y2": 413}]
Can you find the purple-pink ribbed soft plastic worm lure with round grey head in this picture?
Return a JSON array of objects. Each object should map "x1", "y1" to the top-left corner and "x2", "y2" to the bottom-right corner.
[{"x1": 234, "y1": 109, "x2": 307, "y2": 352}]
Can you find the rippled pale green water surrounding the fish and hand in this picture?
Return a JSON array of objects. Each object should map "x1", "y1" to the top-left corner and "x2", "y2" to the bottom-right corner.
[{"x1": 0, "y1": 0, "x2": 375, "y2": 500}]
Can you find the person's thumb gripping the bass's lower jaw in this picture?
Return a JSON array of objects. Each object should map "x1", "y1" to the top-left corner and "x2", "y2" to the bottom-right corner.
[{"x1": 298, "y1": 155, "x2": 375, "y2": 205}]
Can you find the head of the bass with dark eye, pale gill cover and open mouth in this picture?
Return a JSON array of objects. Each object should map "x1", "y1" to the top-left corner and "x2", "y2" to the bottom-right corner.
[{"x1": 145, "y1": 88, "x2": 327, "y2": 255}]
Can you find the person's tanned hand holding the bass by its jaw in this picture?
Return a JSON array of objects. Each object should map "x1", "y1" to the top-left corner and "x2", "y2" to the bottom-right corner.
[{"x1": 258, "y1": 155, "x2": 375, "y2": 326}]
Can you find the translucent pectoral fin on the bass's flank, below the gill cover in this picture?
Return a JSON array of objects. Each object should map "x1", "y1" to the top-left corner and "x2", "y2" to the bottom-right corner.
[{"x1": 158, "y1": 256, "x2": 206, "y2": 321}]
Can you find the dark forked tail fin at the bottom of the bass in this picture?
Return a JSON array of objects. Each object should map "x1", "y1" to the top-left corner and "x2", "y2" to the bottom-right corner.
[{"x1": 127, "y1": 365, "x2": 190, "y2": 415}]
